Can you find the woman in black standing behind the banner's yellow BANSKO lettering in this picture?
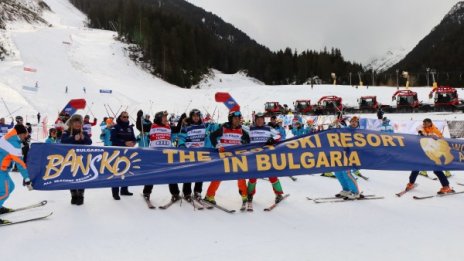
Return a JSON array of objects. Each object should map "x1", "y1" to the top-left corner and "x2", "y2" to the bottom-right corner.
[{"x1": 61, "y1": 114, "x2": 92, "y2": 206}]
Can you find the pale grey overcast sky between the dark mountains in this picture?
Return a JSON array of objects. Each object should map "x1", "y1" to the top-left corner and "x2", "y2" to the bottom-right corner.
[{"x1": 187, "y1": 0, "x2": 459, "y2": 63}]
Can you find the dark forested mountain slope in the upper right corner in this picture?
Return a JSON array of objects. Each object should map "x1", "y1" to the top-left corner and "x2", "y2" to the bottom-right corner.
[{"x1": 389, "y1": 1, "x2": 464, "y2": 86}]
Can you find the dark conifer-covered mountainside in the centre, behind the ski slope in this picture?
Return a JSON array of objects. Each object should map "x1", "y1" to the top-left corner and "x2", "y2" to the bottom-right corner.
[{"x1": 67, "y1": 0, "x2": 362, "y2": 88}]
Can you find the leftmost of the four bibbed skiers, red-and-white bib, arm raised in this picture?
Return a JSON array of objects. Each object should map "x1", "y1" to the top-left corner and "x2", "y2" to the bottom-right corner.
[{"x1": 143, "y1": 111, "x2": 187, "y2": 201}]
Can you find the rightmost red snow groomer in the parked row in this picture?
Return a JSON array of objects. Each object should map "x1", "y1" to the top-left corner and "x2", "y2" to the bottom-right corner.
[{"x1": 429, "y1": 86, "x2": 463, "y2": 111}]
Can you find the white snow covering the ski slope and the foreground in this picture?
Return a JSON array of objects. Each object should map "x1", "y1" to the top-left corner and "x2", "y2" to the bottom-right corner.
[{"x1": 0, "y1": 0, "x2": 464, "y2": 261}]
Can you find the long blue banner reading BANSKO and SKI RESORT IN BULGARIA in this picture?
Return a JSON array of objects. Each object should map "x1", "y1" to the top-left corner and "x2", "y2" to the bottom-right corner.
[{"x1": 27, "y1": 129, "x2": 464, "y2": 190}]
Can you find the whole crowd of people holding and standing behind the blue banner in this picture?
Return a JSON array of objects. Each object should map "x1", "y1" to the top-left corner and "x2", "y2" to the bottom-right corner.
[{"x1": 0, "y1": 106, "x2": 454, "y2": 222}]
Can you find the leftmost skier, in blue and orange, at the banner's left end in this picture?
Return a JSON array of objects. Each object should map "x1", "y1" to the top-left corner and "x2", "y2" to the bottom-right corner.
[{"x1": 0, "y1": 125, "x2": 32, "y2": 224}]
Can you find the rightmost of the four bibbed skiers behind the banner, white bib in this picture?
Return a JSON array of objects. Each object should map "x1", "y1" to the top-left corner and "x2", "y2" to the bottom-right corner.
[{"x1": 247, "y1": 113, "x2": 284, "y2": 203}]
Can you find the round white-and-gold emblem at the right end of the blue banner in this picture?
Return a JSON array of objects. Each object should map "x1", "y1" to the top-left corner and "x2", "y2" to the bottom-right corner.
[{"x1": 420, "y1": 138, "x2": 454, "y2": 165}]
